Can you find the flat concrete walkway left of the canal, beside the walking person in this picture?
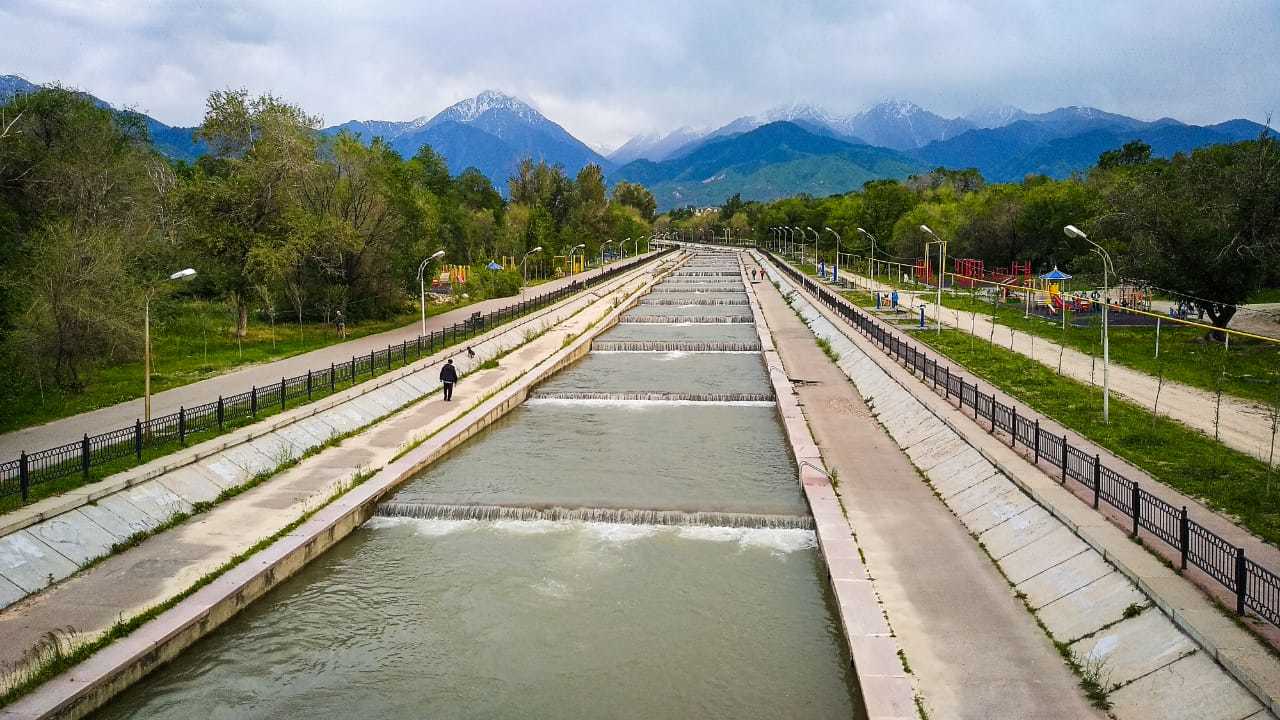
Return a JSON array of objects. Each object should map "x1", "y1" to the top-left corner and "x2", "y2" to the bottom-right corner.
[{"x1": 0, "y1": 260, "x2": 670, "y2": 686}]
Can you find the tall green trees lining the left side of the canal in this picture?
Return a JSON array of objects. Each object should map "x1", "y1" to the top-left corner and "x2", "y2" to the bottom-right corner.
[{"x1": 0, "y1": 87, "x2": 654, "y2": 388}]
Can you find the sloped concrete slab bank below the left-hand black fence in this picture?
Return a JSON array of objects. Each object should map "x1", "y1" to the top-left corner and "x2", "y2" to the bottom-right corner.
[{"x1": 0, "y1": 252, "x2": 675, "y2": 610}]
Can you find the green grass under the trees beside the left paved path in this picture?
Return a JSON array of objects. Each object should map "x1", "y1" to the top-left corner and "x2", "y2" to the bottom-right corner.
[{"x1": 0, "y1": 300, "x2": 483, "y2": 432}]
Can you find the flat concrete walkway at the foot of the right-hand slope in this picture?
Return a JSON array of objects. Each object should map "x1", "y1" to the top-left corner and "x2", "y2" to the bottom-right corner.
[{"x1": 749, "y1": 254, "x2": 1102, "y2": 719}]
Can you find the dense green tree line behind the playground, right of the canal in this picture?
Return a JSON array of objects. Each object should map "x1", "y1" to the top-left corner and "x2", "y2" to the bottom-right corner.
[{"x1": 658, "y1": 133, "x2": 1280, "y2": 327}]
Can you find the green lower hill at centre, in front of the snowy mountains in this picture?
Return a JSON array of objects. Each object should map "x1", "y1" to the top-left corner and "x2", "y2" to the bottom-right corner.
[{"x1": 611, "y1": 122, "x2": 924, "y2": 210}]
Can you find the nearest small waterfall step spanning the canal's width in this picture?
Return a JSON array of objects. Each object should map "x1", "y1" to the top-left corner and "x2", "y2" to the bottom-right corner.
[{"x1": 374, "y1": 502, "x2": 814, "y2": 530}]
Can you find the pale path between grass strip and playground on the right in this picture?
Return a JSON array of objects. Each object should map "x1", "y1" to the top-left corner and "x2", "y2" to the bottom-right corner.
[{"x1": 824, "y1": 267, "x2": 1280, "y2": 461}]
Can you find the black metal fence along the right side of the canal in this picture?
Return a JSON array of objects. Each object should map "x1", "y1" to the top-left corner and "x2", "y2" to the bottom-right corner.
[{"x1": 768, "y1": 254, "x2": 1280, "y2": 625}]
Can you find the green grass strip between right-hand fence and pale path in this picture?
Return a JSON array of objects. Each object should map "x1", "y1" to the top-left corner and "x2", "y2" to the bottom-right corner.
[{"x1": 819, "y1": 285, "x2": 1280, "y2": 544}]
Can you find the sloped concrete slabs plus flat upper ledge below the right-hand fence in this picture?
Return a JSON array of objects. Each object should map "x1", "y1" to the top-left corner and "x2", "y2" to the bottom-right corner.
[{"x1": 772, "y1": 253, "x2": 1280, "y2": 720}]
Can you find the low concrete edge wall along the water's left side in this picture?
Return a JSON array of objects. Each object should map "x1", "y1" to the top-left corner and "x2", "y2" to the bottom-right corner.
[{"x1": 0, "y1": 249, "x2": 684, "y2": 720}]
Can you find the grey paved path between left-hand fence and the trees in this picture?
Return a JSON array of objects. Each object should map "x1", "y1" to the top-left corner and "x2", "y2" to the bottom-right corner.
[{"x1": 0, "y1": 259, "x2": 645, "y2": 460}]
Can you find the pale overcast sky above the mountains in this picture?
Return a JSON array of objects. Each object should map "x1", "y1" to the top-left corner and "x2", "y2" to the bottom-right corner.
[{"x1": 0, "y1": 0, "x2": 1280, "y2": 146}]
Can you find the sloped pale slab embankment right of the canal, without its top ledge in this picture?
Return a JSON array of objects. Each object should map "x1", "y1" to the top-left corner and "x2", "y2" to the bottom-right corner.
[{"x1": 759, "y1": 252, "x2": 1275, "y2": 720}]
